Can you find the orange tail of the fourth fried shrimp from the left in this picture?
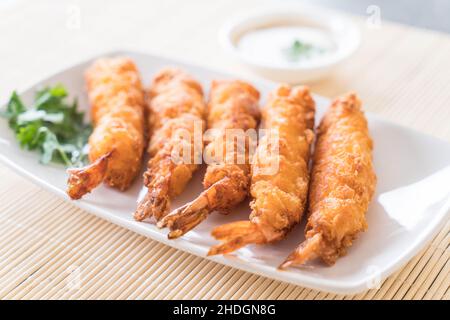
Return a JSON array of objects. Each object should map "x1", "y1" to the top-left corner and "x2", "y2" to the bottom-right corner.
[{"x1": 208, "y1": 221, "x2": 266, "y2": 256}]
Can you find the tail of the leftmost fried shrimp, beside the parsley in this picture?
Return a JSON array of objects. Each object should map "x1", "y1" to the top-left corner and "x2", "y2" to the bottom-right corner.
[{"x1": 67, "y1": 151, "x2": 112, "y2": 200}]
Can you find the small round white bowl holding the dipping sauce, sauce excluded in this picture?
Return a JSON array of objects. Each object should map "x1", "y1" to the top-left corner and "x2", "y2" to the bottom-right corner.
[{"x1": 219, "y1": 6, "x2": 360, "y2": 83}]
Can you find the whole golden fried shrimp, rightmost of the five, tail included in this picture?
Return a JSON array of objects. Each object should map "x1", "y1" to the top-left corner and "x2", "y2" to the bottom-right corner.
[{"x1": 280, "y1": 93, "x2": 376, "y2": 268}]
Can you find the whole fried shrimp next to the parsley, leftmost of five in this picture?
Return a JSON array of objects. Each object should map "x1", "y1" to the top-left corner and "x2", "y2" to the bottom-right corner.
[{"x1": 67, "y1": 57, "x2": 145, "y2": 199}]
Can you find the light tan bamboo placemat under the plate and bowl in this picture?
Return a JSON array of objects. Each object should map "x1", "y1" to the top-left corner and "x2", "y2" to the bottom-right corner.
[{"x1": 0, "y1": 0, "x2": 450, "y2": 299}]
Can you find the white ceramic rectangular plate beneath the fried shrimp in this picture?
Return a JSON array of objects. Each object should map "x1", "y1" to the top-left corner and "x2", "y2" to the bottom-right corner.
[{"x1": 0, "y1": 52, "x2": 450, "y2": 293}]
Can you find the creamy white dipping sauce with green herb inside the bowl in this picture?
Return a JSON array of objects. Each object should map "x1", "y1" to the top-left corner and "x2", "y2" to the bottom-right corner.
[{"x1": 237, "y1": 26, "x2": 336, "y2": 67}]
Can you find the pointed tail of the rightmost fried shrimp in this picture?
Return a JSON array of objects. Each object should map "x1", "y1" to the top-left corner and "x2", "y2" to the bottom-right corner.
[{"x1": 278, "y1": 233, "x2": 323, "y2": 269}]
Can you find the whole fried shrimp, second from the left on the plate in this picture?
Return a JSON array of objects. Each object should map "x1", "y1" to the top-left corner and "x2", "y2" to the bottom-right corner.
[{"x1": 134, "y1": 68, "x2": 206, "y2": 221}]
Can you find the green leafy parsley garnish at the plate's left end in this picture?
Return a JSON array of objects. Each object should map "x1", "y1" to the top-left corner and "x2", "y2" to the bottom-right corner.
[{"x1": 1, "y1": 85, "x2": 92, "y2": 166}]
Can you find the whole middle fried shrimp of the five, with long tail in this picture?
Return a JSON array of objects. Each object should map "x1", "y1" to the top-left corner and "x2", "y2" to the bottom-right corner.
[{"x1": 158, "y1": 80, "x2": 260, "y2": 239}]
